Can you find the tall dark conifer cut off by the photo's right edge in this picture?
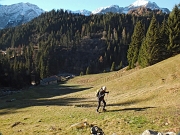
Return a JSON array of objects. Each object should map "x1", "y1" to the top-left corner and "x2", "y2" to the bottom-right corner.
[{"x1": 168, "y1": 4, "x2": 180, "y2": 55}]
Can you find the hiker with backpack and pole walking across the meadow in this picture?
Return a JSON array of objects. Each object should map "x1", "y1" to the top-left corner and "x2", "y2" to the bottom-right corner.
[{"x1": 96, "y1": 86, "x2": 109, "y2": 112}]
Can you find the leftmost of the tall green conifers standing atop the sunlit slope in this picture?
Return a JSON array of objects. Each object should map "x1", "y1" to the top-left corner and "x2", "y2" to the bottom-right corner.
[{"x1": 127, "y1": 21, "x2": 145, "y2": 69}]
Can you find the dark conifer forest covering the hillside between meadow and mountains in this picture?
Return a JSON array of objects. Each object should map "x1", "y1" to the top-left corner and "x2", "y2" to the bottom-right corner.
[{"x1": 0, "y1": 5, "x2": 180, "y2": 87}]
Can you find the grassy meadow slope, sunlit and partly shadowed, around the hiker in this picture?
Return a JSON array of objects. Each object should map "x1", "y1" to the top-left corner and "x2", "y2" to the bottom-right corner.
[{"x1": 0, "y1": 55, "x2": 180, "y2": 135}]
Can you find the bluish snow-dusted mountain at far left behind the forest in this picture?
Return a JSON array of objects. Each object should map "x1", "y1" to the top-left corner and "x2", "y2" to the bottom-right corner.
[{"x1": 0, "y1": 3, "x2": 45, "y2": 29}]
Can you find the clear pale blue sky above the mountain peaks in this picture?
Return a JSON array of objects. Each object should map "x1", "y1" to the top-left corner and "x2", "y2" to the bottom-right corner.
[{"x1": 0, "y1": 0, "x2": 180, "y2": 11}]
